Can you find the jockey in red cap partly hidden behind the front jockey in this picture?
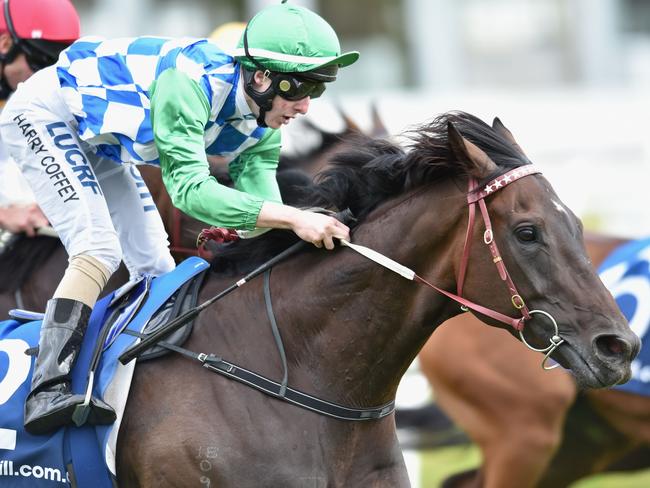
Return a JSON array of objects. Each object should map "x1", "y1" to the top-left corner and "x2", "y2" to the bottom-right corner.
[{"x1": 0, "y1": 0, "x2": 79, "y2": 236}]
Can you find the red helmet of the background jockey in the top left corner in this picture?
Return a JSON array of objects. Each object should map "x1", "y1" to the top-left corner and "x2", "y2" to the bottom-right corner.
[{"x1": 0, "y1": 0, "x2": 79, "y2": 44}]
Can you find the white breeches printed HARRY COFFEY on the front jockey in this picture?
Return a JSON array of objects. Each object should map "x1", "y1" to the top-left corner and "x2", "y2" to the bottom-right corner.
[{"x1": 0, "y1": 67, "x2": 174, "y2": 278}]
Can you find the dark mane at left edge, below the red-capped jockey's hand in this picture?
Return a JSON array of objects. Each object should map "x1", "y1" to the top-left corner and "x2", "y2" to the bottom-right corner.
[{"x1": 0, "y1": 236, "x2": 63, "y2": 293}]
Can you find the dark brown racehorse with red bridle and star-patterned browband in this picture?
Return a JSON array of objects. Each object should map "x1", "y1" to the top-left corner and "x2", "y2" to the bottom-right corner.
[{"x1": 117, "y1": 112, "x2": 639, "y2": 488}]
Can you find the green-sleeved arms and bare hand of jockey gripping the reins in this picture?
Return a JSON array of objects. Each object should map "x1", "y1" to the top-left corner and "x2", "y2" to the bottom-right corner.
[{"x1": 149, "y1": 68, "x2": 349, "y2": 249}]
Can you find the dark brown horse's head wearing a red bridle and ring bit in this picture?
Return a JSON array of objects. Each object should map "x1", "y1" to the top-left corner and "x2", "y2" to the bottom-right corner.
[{"x1": 449, "y1": 115, "x2": 640, "y2": 387}]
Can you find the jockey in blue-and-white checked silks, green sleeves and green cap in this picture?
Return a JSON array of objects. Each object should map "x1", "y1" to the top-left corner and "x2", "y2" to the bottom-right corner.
[{"x1": 0, "y1": 2, "x2": 359, "y2": 434}]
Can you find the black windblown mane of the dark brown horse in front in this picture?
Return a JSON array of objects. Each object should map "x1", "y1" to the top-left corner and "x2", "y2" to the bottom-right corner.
[{"x1": 213, "y1": 112, "x2": 530, "y2": 273}]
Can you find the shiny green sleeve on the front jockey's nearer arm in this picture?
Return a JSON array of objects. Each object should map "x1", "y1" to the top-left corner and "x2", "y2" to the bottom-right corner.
[{"x1": 149, "y1": 68, "x2": 270, "y2": 229}]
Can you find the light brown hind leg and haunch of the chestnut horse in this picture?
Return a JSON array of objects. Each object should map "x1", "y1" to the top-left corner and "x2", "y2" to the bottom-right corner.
[{"x1": 419, "y1": 315, "x2": 575, "y2": 488}]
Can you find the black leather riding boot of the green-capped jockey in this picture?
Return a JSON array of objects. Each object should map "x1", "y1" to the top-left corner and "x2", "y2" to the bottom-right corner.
[{"x1": 25, "y1": 298, "x2": 115, "y2": 435}]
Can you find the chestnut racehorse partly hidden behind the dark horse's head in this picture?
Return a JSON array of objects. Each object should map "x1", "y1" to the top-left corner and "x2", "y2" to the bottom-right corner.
[{"x1": 419, "y1": 233, "x2": 650, "y2": 488}]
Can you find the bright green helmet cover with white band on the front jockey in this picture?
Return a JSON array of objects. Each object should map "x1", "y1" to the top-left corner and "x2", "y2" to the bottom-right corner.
[{"x1": 233, "y1": 3, "x2": 359, "y2": 73}]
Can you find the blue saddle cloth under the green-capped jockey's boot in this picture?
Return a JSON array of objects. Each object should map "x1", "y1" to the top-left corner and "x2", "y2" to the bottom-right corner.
[{"x1": 0, "y1": 258, "x2": 209, "y2": 488}]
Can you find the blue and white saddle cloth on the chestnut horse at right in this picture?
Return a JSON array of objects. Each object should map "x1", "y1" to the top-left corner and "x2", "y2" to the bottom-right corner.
[{"x1": 599, "y1": 238, "x2": 650, "y2": 396}]
